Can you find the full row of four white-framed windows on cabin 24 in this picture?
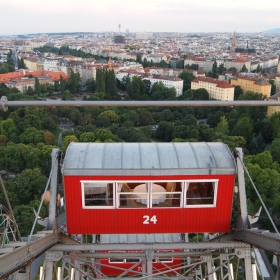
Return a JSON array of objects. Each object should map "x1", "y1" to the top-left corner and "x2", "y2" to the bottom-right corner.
[{"x1": 81, "y1": 179, "x2": 218, "y2": 209}]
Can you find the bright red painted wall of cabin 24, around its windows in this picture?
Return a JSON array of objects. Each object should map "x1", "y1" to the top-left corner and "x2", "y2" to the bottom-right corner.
[{"x1": 64, "y1": 175, "x2": 234, "y2": 234}]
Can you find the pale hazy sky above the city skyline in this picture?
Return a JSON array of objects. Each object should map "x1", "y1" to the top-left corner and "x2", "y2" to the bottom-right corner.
[{"x1": 0, "y1": 0, "x2": 280, "y2": 34}]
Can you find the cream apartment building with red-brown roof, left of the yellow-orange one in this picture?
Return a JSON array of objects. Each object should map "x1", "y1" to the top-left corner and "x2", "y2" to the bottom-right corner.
[{"x1": 191, "y1": 77, "x2": 234, "y2": 101}]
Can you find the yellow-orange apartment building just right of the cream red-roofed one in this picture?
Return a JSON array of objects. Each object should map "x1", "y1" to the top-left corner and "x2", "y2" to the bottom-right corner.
[{"x1": 230, "y1": 73, "x2": 271, "y2": 97}]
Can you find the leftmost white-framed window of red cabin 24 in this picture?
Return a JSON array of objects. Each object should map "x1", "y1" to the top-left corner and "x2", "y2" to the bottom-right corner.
[{"x1": 81, "y1": 181, "x2": 114, "y2": 208}]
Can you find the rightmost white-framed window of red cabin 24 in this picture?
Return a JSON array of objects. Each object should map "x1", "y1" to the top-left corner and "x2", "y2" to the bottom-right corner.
[{"x1": 186, "y1": 181, "x2": 217, "y2": 207}]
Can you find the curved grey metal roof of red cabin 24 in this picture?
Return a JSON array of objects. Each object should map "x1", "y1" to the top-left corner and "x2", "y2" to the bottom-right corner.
[{"x1": 63, "y1": 142, "x2": 236, "y2": 176}]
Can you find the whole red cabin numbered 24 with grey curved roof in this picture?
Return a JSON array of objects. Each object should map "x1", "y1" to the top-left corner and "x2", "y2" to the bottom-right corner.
[{"x1": 62, "y1": 142, "x2": 236, "y2": 234}]
